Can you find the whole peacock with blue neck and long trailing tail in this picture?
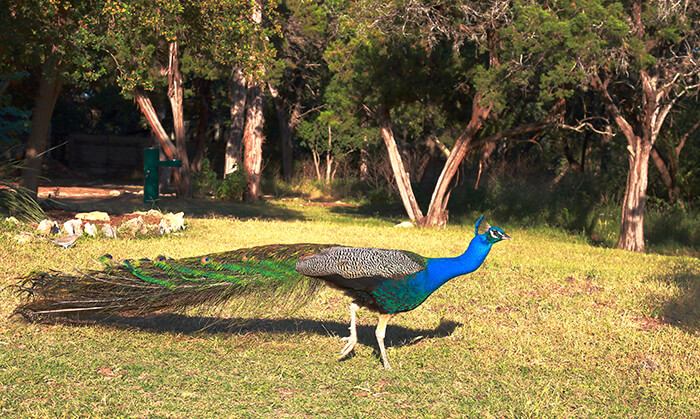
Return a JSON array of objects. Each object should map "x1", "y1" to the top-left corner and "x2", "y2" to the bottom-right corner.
[{"x1": 15, "y1": 216, "x2": 511, "y2": 369}]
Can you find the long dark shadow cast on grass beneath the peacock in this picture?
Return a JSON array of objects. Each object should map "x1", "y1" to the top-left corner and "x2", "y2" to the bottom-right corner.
[{"x1": 41, "y1": 313, "x2": 462, "y2": 349}]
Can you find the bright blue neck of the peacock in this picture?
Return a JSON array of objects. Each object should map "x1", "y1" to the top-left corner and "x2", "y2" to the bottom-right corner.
[{"x1": 423, "y1": 234, "x2": 493, "y2": 292}]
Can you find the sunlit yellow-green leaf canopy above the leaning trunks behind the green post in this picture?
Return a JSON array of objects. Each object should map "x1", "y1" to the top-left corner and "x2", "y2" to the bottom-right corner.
[{"x1": 100, "y1": 0, "x2": 277, "y2": 95}]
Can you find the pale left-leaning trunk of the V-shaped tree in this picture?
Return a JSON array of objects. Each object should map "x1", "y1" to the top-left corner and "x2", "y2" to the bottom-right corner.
[{"x1": 377, "y1": 105, "x2": 423, "y2": 225}]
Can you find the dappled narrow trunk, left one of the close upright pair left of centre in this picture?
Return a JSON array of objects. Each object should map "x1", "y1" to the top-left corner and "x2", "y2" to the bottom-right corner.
[{"x1": 224, "y1": 67, "x2": 247, "y2": 177}]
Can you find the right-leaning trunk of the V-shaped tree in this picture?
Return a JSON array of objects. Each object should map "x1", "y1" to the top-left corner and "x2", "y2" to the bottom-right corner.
[{"x1": 423, "y1": 93, "x2": 492, "y2": 226}]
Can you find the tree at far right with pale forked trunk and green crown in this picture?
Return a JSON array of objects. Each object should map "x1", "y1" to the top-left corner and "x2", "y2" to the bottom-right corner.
[{"x1": 520, "y1": 0, "x2": 700, "y2": 252}]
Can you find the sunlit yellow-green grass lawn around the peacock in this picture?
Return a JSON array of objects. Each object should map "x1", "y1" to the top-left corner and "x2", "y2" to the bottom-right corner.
[{"x1": 0, "y1": 202, "x2": 700, "y2": 418}]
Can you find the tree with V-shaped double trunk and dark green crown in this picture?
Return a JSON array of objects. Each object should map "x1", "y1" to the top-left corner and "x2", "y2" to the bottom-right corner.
[{"x1": 328, "y1": 0, "x2": 562, "y2": 226}]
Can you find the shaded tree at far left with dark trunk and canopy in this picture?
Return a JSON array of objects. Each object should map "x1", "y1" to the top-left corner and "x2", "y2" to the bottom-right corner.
[{"x1": 0, "y1": 0, "x2": 104, "y2": 198}]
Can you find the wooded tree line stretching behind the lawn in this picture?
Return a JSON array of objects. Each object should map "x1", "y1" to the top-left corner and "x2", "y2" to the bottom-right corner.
[{"x1": 0, "y1": 0, "x2": 700, "y2": 252}]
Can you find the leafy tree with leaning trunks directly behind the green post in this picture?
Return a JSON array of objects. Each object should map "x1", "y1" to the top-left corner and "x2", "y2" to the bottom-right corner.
[{"x1": 102, "y1": 0, "x2": 256, "y2": 196}]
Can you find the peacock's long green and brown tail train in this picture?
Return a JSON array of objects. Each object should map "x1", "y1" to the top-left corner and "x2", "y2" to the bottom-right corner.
[{"x1": 15, "y1": 244, "x2": 332, "y2": 320}]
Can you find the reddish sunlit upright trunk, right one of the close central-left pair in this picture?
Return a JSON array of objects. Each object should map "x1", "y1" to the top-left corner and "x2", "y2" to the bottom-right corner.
[{"x1": 243, "y1": 85, "x2": 265, "y2": 202}]
